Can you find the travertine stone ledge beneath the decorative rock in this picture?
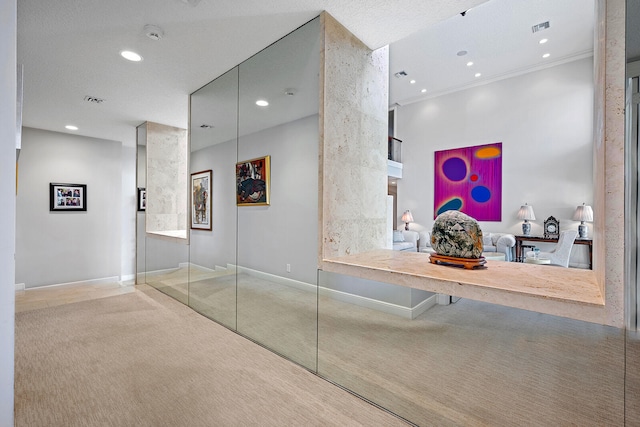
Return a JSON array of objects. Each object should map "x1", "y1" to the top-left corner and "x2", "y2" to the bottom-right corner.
[{"x1": 322, "y1": 249, "x2": 608, "y2": 324}]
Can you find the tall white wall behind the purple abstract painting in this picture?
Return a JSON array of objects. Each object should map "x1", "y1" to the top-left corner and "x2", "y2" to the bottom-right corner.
[{"x1": 396, "y1": 58, "x2": 594, "y2": 264}]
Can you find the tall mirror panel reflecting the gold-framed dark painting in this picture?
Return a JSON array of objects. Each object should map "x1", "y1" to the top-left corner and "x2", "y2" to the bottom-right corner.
[{"x1": 235, "y1": 19, "x2": 320, "y2": 369}]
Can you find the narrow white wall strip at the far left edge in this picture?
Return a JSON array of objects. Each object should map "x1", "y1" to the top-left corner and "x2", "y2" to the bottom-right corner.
[{"x1": 0, "y1": 0, "x2": 17, "y2": 427}]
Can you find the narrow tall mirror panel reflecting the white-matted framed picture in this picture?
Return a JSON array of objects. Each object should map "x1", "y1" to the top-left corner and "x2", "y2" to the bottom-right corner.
[{"x1": 189, "y1": 67, "x2": 238, "y2": 329}]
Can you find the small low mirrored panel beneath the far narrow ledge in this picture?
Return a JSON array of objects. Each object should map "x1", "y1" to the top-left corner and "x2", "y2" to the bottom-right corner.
[{"x1": 145, "y1": 234, "x2": 189, "y2": 304}]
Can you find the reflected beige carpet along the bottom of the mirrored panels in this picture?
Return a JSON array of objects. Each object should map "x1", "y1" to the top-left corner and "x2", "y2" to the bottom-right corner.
[{"x1": 140, "y1": 275, "x2": 640, "y2": 426}]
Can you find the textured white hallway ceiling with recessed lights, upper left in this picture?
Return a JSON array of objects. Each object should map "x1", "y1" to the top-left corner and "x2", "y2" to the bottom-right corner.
[{"x1": 18, "y1": 0, "x2": 485, "y2": 145}]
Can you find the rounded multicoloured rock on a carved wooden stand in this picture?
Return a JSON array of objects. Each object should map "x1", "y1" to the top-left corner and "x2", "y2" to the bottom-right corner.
[{"x1": 429, "y1": 211, "x2": 486, "y2": 269}]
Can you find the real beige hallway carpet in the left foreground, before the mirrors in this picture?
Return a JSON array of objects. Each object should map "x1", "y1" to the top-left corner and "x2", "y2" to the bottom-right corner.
[{"x1": 15, "y1": 287, "x2": 406, "y2": 427}]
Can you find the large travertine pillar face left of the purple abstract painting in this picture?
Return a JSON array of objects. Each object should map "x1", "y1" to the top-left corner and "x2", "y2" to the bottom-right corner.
[{"x1": 318, "y1": 12, "x2": 389, "y2": 265}]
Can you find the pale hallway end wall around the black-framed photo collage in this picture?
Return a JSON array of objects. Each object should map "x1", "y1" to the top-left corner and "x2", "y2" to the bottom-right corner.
[{"x1": 16, "y1": 128, "x2": 124, "y2": 287}]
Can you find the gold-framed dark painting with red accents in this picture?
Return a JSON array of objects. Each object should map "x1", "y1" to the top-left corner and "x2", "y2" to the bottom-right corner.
[{"x1": 236, "y1": 156, "x2": 271, "y2": 206}]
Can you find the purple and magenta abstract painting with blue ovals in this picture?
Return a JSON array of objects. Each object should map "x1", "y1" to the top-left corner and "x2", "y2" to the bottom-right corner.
[{"x1": 434, "y1": 142, "x2": 502, "y2": 221}]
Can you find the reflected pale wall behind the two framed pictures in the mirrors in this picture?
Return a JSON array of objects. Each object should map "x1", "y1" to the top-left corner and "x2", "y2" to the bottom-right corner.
[{"x1": 190, "y1": 115, "x2": 318, "y2": 283}]
